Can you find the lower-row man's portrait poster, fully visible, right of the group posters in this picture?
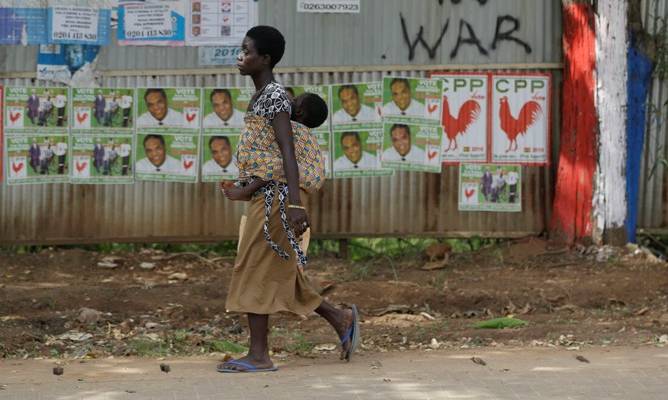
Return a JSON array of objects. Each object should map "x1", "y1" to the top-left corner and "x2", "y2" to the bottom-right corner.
[{"x1": 135, "y1": 131, "x2": 199, "y2": 183}]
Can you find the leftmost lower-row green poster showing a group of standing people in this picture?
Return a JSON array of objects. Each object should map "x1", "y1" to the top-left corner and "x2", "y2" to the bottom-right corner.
[{"x1": 5, "y1": 134, "x2": 69, "y2": 185}]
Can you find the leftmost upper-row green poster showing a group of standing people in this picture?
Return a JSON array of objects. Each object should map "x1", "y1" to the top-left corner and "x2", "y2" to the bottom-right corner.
[{"x1": 4, "y1": 87, "x2": 70, "y2": 133}]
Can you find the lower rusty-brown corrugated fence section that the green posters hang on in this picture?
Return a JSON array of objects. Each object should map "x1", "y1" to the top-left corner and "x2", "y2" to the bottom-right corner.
[{"x1": 0, "y1": 71, "x2": 560, "y2": 243}]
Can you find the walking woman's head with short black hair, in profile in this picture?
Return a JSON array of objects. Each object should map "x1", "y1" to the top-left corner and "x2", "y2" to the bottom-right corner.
[{"x1": 237, "y1": 25, "x2": 285, "y2": 75}]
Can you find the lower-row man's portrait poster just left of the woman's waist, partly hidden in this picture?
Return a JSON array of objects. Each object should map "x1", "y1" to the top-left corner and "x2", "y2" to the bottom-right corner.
[{"x1": 202, "y1": 133, "x2": 239, "y2": 182}]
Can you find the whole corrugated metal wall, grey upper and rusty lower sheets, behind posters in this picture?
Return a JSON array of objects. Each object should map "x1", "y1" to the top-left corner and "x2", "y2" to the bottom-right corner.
[{"x1": 0, "y1": 0, "x2": 561, "y2": 243}]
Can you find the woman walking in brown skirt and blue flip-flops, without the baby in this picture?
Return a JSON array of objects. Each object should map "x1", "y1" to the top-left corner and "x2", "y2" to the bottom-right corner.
[{"x1": 217, "y1": 26, "x2": 359, "y2": 373}]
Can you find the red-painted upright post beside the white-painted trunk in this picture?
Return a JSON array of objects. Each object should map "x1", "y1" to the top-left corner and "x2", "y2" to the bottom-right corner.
[{"x1": 551, "y1": 3, "x2": 597, "y2": 242}]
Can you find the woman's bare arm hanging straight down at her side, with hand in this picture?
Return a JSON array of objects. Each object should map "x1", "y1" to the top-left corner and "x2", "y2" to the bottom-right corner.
[{"x1": 271, "y1": 112, "x2": 308, "y2": 236}]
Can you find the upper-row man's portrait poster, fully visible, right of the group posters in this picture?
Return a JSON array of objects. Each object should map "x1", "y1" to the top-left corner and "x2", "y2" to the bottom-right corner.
[{"x1": 136, "y1": 88, "x2": 201, "y2": 130}]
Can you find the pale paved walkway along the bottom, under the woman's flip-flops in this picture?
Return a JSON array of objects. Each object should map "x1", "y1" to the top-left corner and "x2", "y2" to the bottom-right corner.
[{"x1": 0, "y1": 347, "x2": 668, "y2": 400}]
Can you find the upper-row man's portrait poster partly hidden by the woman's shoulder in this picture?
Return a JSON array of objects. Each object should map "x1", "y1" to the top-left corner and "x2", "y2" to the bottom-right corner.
[{"x1": 202, "y1": 87, "x2": 250, "y2": 134}]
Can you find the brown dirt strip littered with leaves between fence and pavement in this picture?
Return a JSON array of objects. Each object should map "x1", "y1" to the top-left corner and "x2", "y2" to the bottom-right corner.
[{"x1": 0, "y1": 239, "x2": 668, "y2": 358}]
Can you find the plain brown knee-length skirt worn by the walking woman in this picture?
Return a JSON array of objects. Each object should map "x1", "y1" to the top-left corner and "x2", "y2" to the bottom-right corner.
[{"x1": 225, "y1": 188, "x2": 322, "y2": 315}]
